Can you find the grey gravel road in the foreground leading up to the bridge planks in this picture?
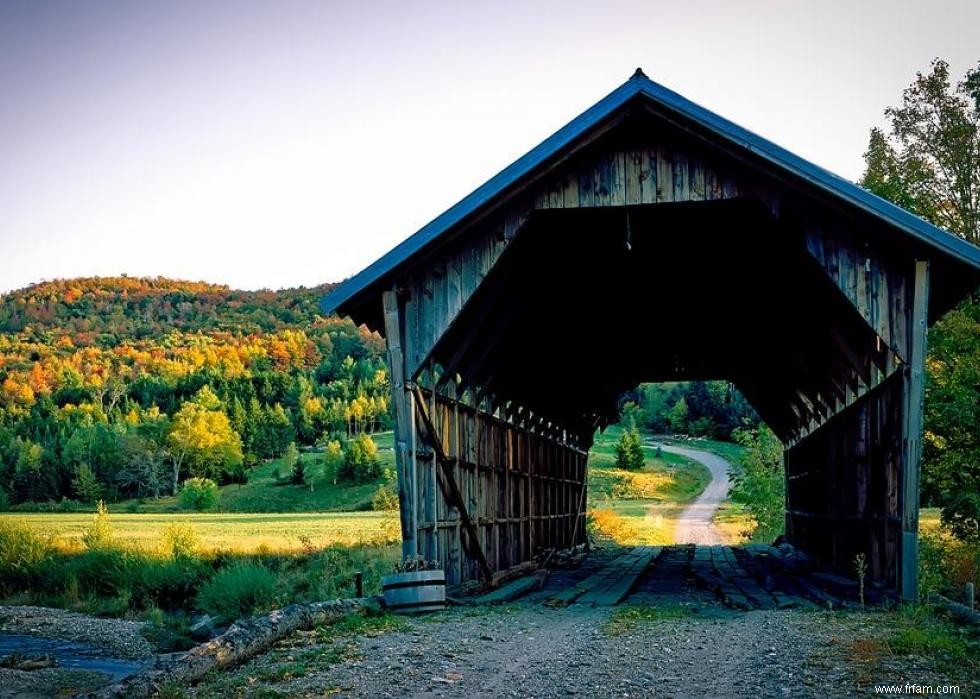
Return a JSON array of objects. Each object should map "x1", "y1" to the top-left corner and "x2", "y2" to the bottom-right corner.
[{"x1": 199, "y1": 604, "x2": 971, "y2": 699}]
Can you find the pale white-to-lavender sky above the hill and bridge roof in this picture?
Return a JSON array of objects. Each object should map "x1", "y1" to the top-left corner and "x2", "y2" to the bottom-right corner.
[{"x1": 0, "y1": 0, "x2": 980, "y2": 292}]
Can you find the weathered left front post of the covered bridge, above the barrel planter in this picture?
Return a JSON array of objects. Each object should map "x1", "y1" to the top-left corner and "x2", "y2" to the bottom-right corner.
[{"x1": 382, "y1": 290, "x2": 418, "y2": 558}]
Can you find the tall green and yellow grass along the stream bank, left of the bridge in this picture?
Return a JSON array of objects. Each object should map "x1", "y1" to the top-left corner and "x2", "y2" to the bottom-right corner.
[{"x1": 0, "y1": 508, "x2": 399, "y2": 620}]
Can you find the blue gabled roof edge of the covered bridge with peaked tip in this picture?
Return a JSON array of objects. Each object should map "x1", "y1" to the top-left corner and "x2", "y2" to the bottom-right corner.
[{"x1": 322, "y1": 69, "x2": 980, "y2": 313}]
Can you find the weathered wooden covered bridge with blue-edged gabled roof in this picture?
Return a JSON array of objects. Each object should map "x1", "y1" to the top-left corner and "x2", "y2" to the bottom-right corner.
[{"x1": 324, "y1": 70, "x2": 980, "y2": 598}]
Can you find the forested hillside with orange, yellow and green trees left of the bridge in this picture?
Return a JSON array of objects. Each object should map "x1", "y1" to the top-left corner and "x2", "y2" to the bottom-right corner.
[{"x1": 0, "y1": 277, "x2": 389, "y2": 506}]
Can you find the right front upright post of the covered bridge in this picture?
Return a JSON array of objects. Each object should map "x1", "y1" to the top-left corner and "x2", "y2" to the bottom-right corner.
[{"x1": 898, "y1": 260, "x2": 929, "y2": 601}]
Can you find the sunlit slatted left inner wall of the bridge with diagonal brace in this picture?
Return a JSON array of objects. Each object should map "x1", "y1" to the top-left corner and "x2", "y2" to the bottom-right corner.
[{"x1": 413, "y1": 382, "x2": 587, "y2": 584}]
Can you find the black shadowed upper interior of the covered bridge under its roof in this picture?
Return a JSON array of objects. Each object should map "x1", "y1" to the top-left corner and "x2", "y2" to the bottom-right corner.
[{"x1": 432, "y1": 199, "x2": 880, "y2": 440}]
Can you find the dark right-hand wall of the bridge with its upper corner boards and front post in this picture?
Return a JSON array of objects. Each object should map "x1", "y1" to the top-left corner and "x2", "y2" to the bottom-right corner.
[{"x1": 786, "y1": 241, "x2": 929, "y2": 599}]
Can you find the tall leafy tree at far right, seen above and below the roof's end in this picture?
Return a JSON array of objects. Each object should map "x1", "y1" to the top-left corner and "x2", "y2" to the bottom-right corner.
[{"x1": 861, "y1": 59, "x2": 980, "y2": 541}]
